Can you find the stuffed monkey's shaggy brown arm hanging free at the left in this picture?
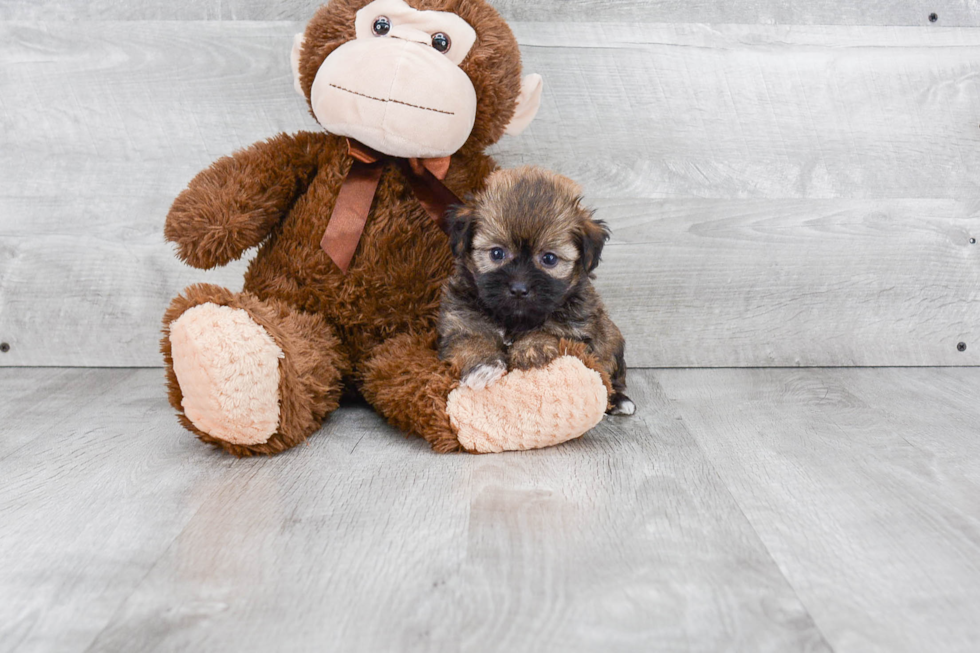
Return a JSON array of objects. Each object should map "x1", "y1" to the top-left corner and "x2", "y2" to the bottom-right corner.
[{"x1": 164, "y1": 132, "x2": 322, "y2": 269}]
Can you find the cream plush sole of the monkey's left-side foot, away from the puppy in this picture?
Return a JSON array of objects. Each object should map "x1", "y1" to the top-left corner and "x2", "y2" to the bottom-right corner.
[{"x1": 170, "y1": 303, "x2": 283, "y2": 445}]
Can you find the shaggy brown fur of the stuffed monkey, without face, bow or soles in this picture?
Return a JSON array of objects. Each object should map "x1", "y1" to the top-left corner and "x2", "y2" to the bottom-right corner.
[{"x1": 161, "y1": 0, "x2": 544, "y2": 456}]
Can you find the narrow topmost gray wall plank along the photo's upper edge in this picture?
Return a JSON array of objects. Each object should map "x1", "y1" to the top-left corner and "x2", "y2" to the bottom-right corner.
[{"x1": 0, "y1": 0, "x2": 980, "y2": 27}]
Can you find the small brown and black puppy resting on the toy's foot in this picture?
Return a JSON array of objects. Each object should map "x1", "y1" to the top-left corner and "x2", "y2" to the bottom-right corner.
[{"x1": 439, "y1": 167, "x2": 636, "y2": 415}]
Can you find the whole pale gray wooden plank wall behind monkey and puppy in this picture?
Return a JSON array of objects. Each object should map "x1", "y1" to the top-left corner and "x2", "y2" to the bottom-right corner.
[{"x1": 0, "y1": 0, "x2": 980, "y2": 367}]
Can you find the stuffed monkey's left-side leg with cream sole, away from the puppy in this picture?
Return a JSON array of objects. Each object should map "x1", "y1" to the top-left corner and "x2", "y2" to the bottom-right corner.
[{"x1": 161, "y1": 284, "x2": 349, "y2": 456}]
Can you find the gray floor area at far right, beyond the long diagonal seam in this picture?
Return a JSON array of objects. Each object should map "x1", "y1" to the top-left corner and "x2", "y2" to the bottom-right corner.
[{"x1": 656, "y1": 369, "x2": 980, "y2": 653}]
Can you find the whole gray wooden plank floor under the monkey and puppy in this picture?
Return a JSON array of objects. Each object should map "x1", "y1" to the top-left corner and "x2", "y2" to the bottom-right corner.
[{"x1": 0, "y1": 368, "x2": 980, "y2": 652}]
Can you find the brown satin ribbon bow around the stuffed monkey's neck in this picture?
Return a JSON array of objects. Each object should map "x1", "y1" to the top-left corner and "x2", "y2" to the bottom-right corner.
[{"x1": 320, "y1": 138, "x2": 459, "y2": 274}]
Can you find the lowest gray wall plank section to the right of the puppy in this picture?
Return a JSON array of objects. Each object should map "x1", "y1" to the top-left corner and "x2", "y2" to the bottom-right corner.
[{"x1": 596, "y1": 200, "x2": 980, "y2": 367}]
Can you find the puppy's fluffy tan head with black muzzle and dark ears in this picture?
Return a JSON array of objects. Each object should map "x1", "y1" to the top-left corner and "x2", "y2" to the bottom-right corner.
[{"x1": 451, "y1": 168, "x2": 609, "y2": 331}]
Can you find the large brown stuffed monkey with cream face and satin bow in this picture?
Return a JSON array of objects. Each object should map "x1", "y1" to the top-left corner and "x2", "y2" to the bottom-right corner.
[{"x1": 161, "y1": 0, "x2": 608, "y2": 456}]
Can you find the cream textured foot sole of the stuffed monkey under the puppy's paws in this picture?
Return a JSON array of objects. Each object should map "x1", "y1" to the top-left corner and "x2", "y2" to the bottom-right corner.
[{"x1": 447, "y1": 356, "x2": 607, "y2": 453}]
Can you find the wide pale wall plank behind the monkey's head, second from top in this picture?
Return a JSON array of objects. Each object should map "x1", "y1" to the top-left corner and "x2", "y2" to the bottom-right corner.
[{"x1": 0, "y1": 22, "x2": 980, "y2": 201}]
